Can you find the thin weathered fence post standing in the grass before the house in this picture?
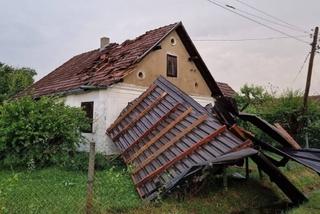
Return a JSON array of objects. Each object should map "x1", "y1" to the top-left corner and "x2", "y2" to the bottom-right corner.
[{"x1": 86, "y1": 142, "x2": 96, "y2": 214}]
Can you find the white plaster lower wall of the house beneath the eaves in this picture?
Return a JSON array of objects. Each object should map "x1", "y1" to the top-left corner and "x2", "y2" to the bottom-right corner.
[{"x1": 64, "y1": 83, "x2": 214, "y2": 155}]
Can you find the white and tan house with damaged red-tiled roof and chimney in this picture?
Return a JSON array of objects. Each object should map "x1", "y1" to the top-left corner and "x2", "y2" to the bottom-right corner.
[{"x1": 20, "y1": 22, "x2": 234, "y2": 154}]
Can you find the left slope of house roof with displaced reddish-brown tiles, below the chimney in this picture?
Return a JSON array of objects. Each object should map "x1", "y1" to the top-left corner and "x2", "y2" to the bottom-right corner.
[{"x1": 18, "y1": 23, "x2": 179, "y2": 97}]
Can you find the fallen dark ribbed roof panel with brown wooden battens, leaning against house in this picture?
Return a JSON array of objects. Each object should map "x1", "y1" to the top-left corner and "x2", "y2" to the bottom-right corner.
[{"x1": 107, "y1": 77, "x2": 251, "y2": 198}]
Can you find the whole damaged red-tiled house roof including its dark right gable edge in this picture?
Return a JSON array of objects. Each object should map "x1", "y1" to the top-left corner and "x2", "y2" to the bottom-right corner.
[{"x1": 18, "y1": 22, "x2": 234, "y2": 97}]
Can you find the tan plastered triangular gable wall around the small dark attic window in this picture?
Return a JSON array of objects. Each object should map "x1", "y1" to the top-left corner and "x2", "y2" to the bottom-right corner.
[{"x1": 123, "y1": 30, "x2": 212, "y2": 96}]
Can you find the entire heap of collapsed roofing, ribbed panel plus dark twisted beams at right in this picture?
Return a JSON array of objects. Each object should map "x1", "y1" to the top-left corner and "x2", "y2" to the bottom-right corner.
[{"x1": 107, "y1": 77, "x2": 320, "y2": 204}]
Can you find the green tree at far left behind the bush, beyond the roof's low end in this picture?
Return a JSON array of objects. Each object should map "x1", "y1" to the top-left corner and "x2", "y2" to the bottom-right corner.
[{"x1": 0, "y1": 62, "x2": 37, "y2": 103}]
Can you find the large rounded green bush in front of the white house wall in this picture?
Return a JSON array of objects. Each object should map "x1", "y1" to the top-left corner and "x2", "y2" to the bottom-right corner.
[{"x1": 0, "y1": 97, "x2": 89, "y2": 168}]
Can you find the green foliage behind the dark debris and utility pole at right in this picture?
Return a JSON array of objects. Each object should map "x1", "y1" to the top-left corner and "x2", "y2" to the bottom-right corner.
[{"x1": 236, "y1": 85, "x2": 320, "y2": 148}]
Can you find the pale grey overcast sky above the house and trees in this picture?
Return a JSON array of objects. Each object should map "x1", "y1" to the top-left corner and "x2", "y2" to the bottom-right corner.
[{"x1": 0, "y1": 0, "x2": 320, "y2": 94}]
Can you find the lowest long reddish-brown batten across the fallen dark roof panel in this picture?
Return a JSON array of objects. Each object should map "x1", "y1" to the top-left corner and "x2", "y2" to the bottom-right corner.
[{"x1": 136, "y1": 125, "x2": 227, "y2": 186}]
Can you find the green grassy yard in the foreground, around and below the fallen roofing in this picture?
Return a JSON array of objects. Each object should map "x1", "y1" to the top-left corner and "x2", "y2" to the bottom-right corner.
[{"x1": 0, "y1": 163, "x2": 320, "y2": 214}]
